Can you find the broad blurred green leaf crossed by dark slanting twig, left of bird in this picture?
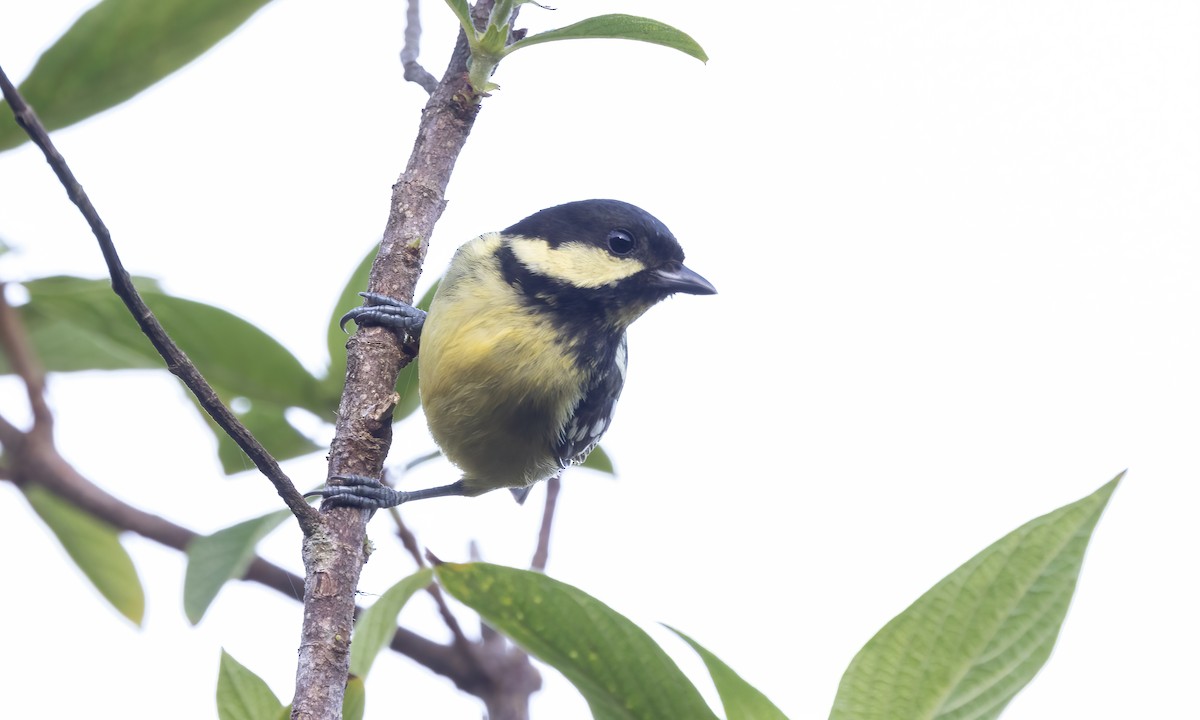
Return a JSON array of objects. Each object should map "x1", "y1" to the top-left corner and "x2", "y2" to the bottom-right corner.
[{"x1": 0, "y1": 276, "x2": 331, "y2": 414}]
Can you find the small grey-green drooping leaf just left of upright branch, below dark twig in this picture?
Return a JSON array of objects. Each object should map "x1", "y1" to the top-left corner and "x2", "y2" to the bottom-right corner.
[{"x1": 184, "y1": 510, "x2": 292, "y2": 625}]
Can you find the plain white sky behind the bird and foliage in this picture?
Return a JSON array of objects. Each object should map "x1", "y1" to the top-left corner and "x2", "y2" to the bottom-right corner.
[{"x1": 0, "y1": 0, "x2": 1200, "y2": 720}]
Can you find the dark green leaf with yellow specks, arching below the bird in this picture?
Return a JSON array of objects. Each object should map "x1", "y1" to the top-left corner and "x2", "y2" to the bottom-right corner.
[{"x1": 434, "y1": 563, "x2": 715, "y2": 720}]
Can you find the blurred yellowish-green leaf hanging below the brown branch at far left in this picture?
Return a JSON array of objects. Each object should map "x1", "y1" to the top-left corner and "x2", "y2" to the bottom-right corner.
[{"x1": 24, "y1": 485, "x2": 145, "y2": 625}]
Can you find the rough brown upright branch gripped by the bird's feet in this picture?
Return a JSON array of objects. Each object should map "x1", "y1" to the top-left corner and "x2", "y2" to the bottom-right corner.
[{"x1": 292, "y1": 0, "x2": 499, "y2": 720}]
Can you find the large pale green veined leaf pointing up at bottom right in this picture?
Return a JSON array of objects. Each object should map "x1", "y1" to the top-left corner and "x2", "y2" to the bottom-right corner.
[{"x1": 829, "y1": 475, "x2": 1121, "y2": 720}]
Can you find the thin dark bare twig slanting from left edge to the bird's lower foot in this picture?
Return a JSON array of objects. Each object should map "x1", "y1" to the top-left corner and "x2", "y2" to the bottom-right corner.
[{"x1": 0, "y1": 63, "x2": 319, "y2": 535}]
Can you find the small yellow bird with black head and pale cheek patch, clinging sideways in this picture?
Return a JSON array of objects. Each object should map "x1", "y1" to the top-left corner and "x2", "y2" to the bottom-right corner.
[{"x1": 313, "y1": 199, "x2": 716, "y2": 510}]
